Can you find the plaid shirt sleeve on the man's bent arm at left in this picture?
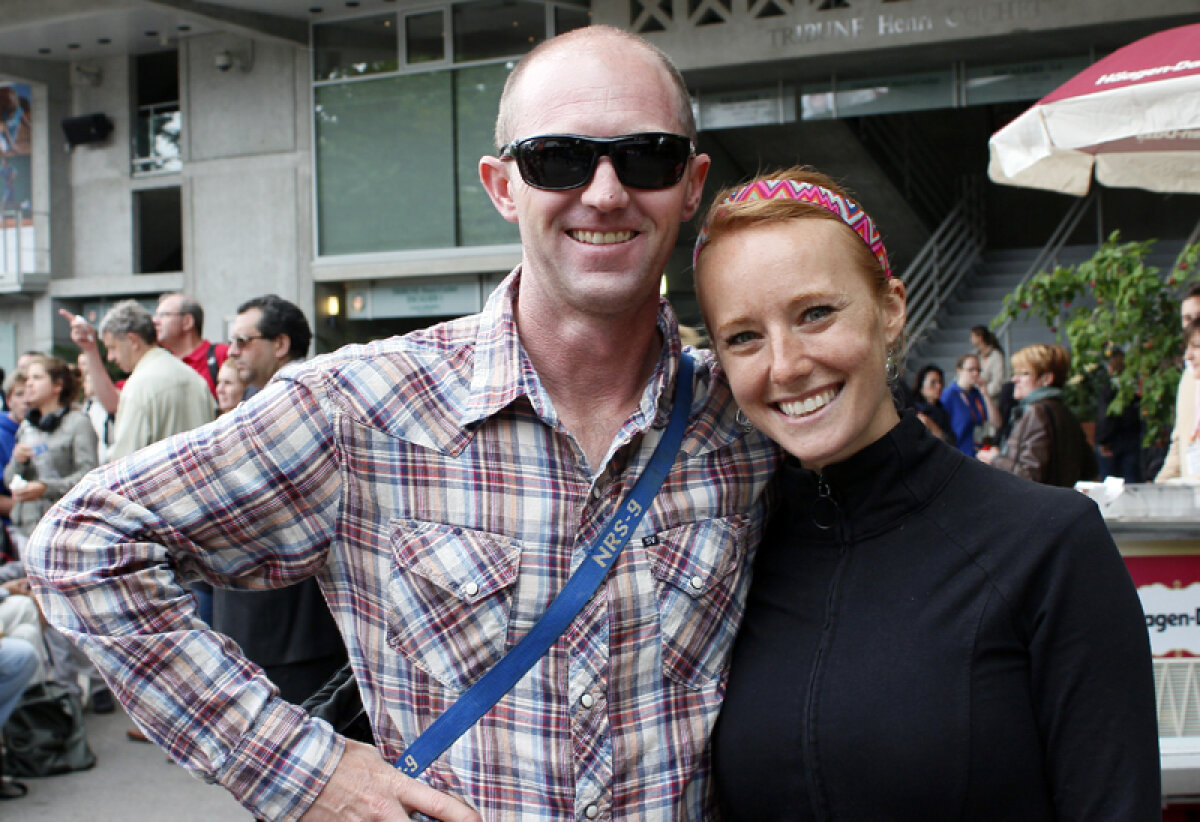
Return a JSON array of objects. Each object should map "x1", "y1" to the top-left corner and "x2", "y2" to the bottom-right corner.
[{"x1": 26, "y1": 380, "x2": 344, "y2": 820}]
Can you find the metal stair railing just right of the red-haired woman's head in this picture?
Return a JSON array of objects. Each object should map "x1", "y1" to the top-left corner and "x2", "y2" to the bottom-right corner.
[{"x1": 900, "y1": 178, "x2": 985, "y2": 354}]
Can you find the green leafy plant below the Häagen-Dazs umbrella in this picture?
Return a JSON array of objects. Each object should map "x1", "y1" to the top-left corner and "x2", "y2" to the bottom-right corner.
[{"x1": 992, "y1": 232, "x2": 1200, "y2": 445}]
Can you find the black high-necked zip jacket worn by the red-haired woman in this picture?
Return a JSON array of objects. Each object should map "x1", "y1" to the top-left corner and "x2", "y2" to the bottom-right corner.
[{"x1": 713, "y1": 415, "x2": 1162, "y2": 822}]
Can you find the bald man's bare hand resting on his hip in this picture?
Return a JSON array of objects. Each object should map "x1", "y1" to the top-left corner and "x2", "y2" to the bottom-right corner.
[{"x1": 300, "y1": 742, "x2": 482, "y2": 822}]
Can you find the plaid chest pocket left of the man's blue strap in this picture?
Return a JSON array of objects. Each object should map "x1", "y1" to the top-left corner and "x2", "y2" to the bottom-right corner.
[{"x1": 388, "y1": 518, "x2": 521, "y2": 691}]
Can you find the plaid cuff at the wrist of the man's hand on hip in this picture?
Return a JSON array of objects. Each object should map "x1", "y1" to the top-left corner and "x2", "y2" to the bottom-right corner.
[{"x1": 217, "y1": 698, "x2": 346, "y2": 821}]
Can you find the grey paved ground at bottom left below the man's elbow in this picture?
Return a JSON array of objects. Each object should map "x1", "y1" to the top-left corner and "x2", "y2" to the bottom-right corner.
[{"x1": 0, "y1": 710, "x2": 252, "y2": 822}]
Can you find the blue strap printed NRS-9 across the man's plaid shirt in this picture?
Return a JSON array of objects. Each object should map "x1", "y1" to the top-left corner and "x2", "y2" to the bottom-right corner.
[{"x1": 396, "y1": 354, "x2": 694, "y2": 776}]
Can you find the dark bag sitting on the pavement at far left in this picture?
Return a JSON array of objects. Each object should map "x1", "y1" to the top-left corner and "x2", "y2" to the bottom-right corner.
[{"x1": 4, "y1": 682, "x2": 96, "y2": 776}]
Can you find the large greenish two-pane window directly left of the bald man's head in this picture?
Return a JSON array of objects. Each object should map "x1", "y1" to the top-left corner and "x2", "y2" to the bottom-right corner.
[{"x1": 316, "y1": 64, "x2": 518, "y2": 254}]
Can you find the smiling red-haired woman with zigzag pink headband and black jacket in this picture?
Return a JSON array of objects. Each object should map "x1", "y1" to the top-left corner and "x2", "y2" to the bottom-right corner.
[{"x1": 696, "y1": 168, "x2": 1160, "y2": 822}]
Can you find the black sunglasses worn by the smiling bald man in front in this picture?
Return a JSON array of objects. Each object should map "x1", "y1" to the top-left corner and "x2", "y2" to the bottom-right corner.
[{"x1": 500, "y1": 132, "x2": 695, "y2": 191}]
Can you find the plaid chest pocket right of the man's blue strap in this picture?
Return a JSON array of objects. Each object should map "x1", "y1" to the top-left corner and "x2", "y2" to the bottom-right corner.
[{"x1": 647, "y1": 516, "x2": 749, "y2": 688}]
